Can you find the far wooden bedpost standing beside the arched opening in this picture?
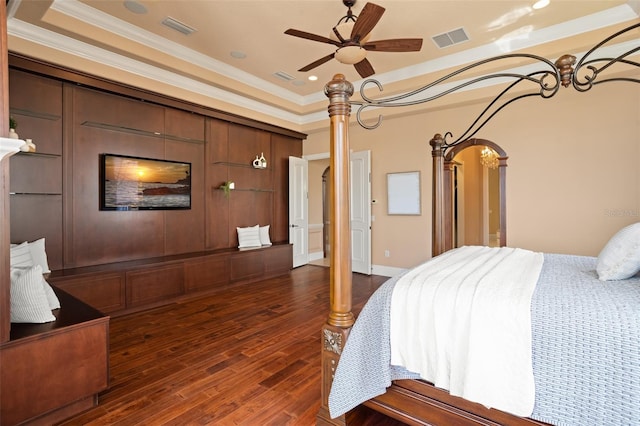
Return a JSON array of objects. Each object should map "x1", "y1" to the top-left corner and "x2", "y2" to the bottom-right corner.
[{"x1": 429, "y1": 134, "x2": 445, "y2": 257}]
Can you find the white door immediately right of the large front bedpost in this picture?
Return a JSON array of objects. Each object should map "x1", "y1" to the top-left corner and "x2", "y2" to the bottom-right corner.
[{"x1": 350, "y1": 151, "x2": 371, "y2": 275}]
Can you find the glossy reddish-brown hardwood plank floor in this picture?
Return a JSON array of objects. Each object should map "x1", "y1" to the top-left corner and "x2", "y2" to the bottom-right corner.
[{"x1": 58, "y1": 265, "x2": 395, "y2": 426}]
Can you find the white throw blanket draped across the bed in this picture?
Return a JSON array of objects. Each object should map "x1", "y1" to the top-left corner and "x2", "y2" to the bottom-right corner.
[{"x1": 390, "y1": 246, "x2": 543, "y2": 416}]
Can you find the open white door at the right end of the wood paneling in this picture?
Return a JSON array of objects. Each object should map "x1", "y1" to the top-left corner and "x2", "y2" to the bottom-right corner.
[{"x1": 289, "y1": 157, "x2": 309, "y2": 268}]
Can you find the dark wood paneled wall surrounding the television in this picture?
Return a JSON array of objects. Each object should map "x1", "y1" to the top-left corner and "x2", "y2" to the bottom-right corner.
[{"x1": 9, "y1": 60, "x2": 304, "y2": 270}]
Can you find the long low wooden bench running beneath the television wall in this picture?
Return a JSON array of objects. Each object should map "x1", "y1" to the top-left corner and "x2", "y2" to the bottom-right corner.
[{"x1": 47, "y1": 243, "x2": 293, "y2": 316}]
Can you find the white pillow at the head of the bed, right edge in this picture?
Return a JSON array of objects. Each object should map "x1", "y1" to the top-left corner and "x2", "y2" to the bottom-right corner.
[{"x1": 596, "y1": 222, "x2": 640, "y2": 281}]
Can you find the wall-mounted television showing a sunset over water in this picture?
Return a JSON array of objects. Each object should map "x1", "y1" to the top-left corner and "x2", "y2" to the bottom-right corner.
[{"x1": 100, "y1": 154, "x2": 191, "y2": 210}]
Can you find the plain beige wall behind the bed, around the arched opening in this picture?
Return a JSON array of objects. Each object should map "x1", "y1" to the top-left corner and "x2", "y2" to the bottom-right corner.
[{"x1": 304, "y1": 83, "x2": 640, "y2": 268}]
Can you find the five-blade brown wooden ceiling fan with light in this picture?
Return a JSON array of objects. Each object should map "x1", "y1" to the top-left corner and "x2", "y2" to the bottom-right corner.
[{"x1": 284, "y1": 0, "x2": 422, "y2": 78}]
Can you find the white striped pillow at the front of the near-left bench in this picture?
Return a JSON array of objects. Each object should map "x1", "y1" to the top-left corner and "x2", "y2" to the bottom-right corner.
[{"x1": 10, "y1": 265, "x2": 56, "y2": 324}]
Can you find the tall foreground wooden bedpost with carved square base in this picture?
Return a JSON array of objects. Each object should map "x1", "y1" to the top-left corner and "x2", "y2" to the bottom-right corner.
[{"x1": 317, "y1": 74, "x2": 355, "y2": 425}]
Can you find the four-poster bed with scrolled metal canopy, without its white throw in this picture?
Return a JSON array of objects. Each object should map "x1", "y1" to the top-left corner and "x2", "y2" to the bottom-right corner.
[{"x1": 318, "y1": 24, "x2": 640, "y2": 425}]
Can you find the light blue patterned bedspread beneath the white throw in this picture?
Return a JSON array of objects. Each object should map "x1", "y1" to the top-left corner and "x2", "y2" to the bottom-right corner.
[{"x1": 329, "y1": 254, "x2": 640, "y2": 426}]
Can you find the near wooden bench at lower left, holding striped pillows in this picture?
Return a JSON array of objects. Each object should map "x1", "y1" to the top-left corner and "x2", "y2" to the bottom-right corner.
[{"x1": 0, "y1": 289, "x2": 109, "y2": 425}]
